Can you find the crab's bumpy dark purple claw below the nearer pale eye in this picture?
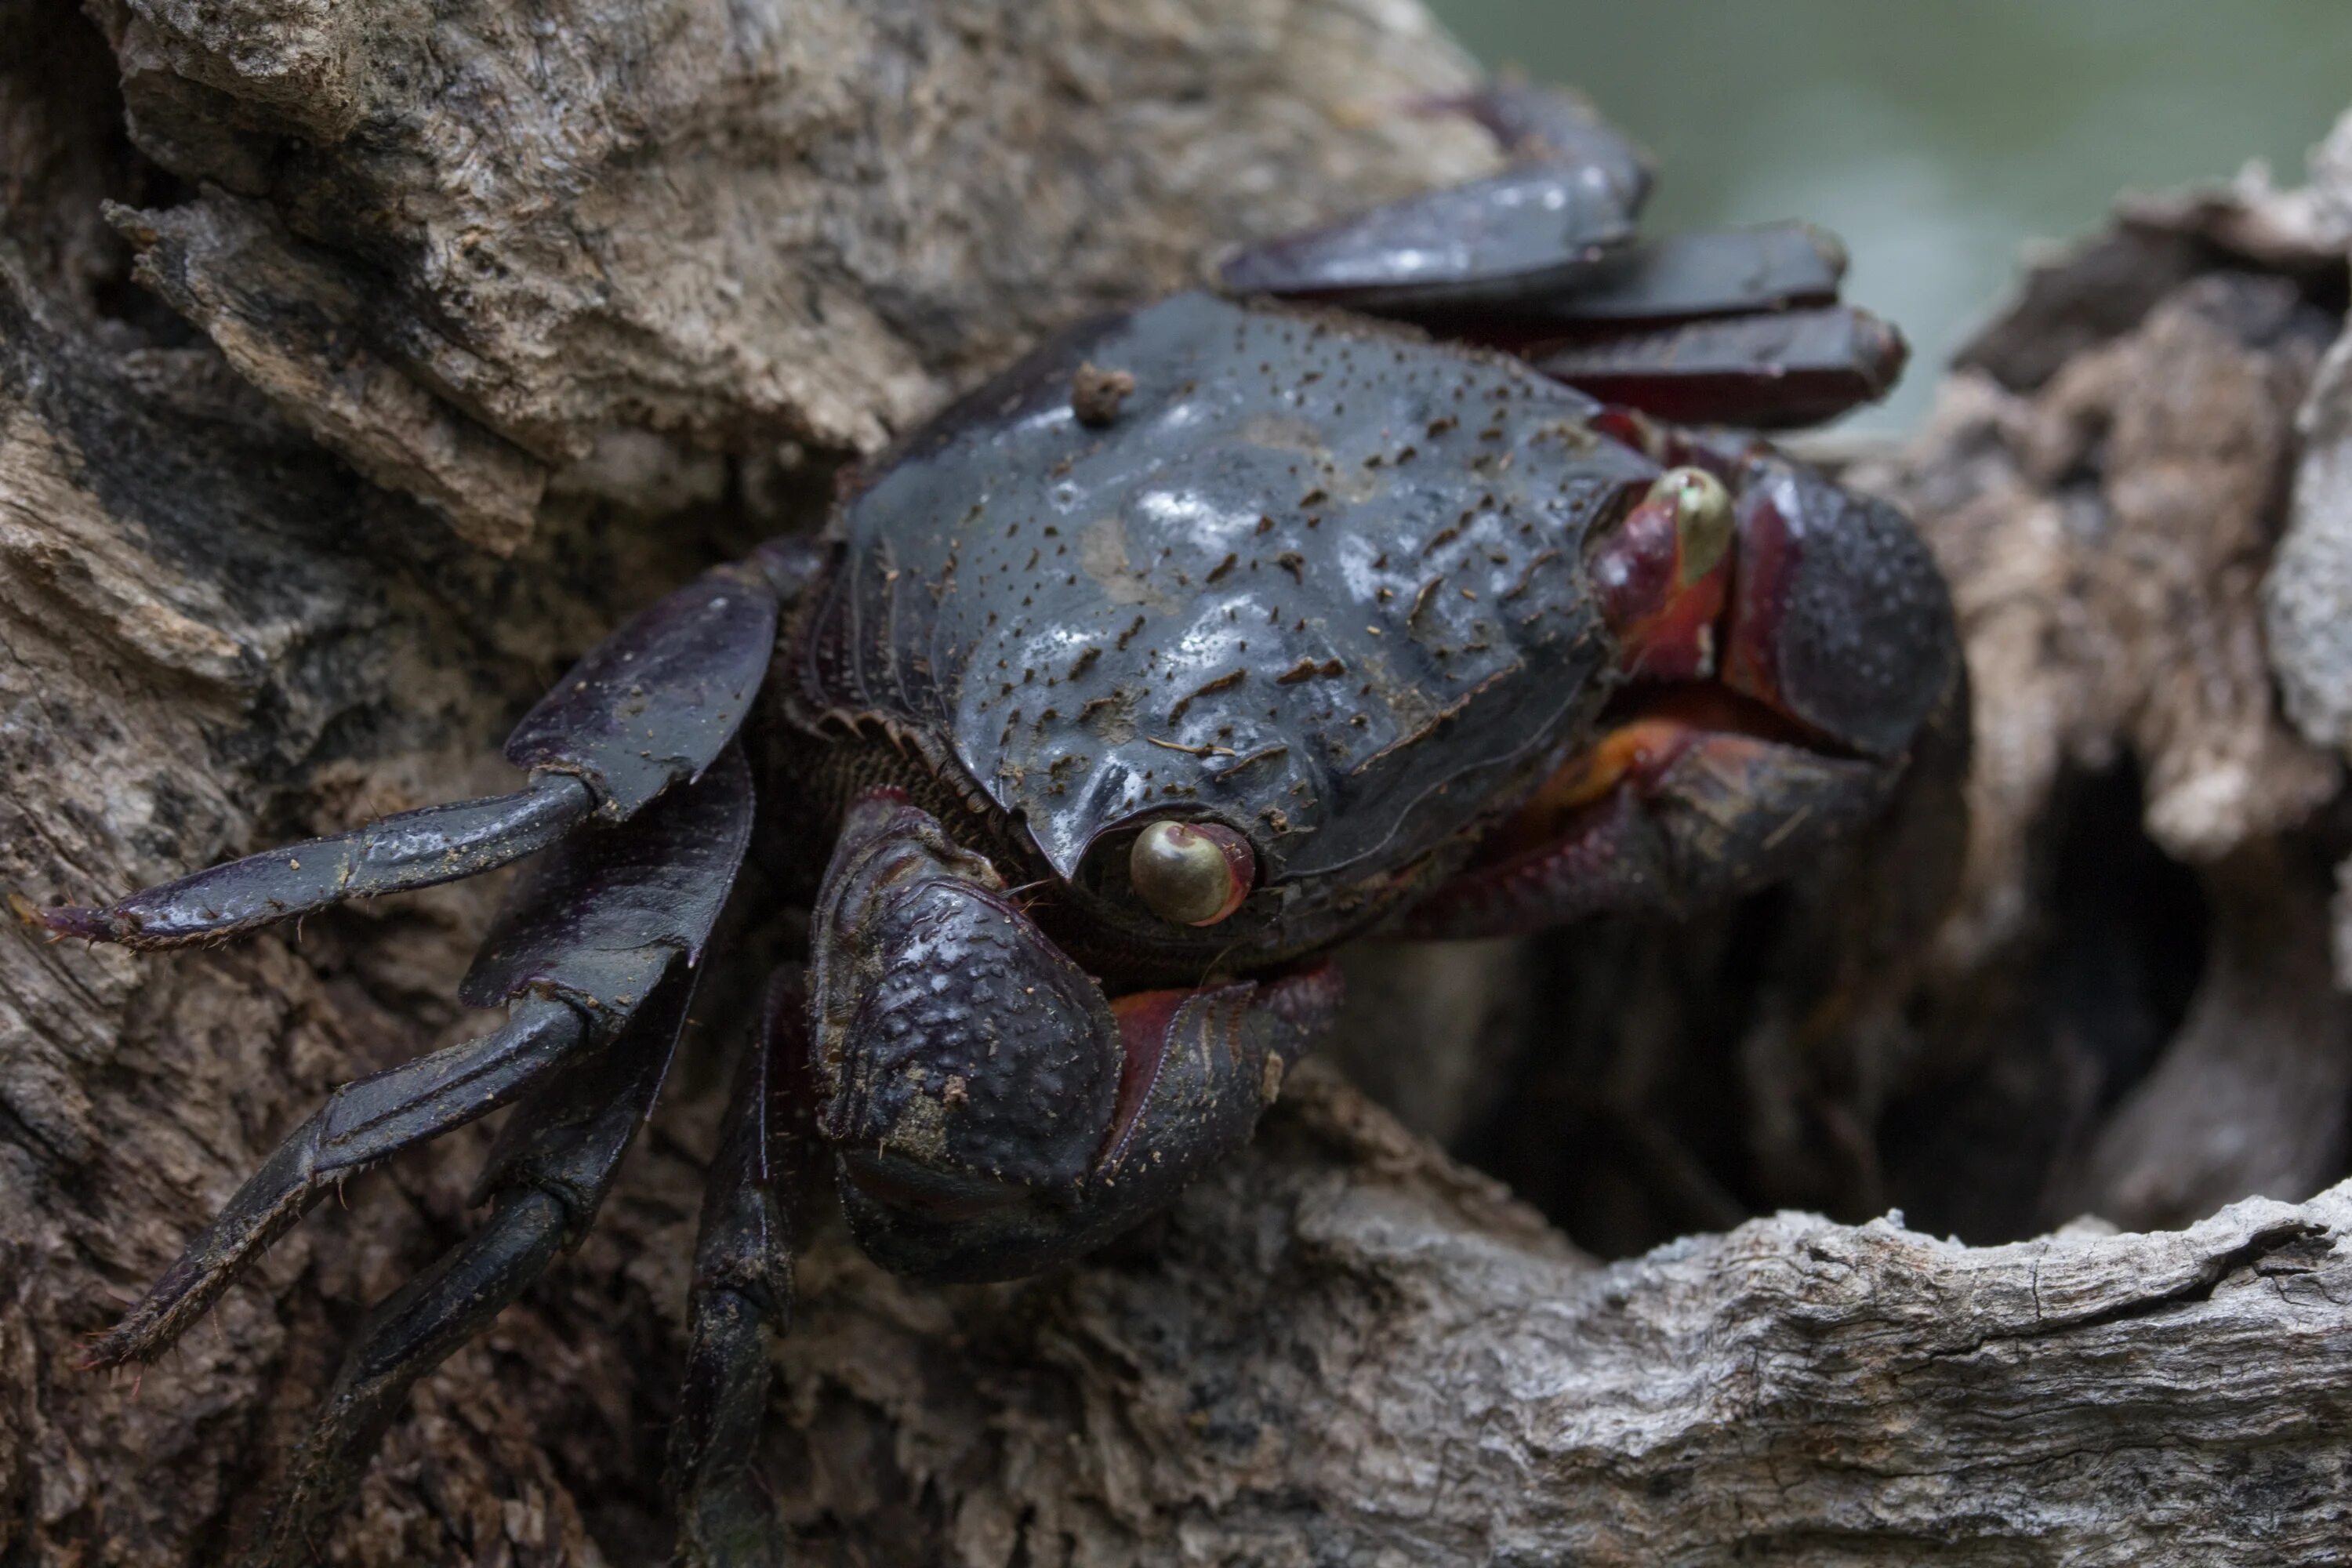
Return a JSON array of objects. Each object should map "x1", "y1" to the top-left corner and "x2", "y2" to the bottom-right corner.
[{"x1": 809, "y1": 792, "x2": 1336, "y2": 1279}]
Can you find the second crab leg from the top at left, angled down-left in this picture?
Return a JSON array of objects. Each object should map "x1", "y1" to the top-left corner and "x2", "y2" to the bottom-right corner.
[{"x1": 89, "y1": 750, "x2": 750, "y2": 1366}]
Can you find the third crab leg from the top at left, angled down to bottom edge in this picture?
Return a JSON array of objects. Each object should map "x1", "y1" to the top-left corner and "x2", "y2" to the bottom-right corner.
[{"x1": 249, "y1": 968, "x2": 694, "y2": 1568}]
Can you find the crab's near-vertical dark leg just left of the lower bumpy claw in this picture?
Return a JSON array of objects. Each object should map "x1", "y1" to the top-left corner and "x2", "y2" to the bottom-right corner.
[{"x1": 666, "y1": 971, "x2": 821, "y2": 1563}]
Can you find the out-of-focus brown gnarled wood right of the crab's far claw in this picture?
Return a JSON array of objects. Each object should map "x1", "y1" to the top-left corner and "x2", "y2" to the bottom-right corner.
[{"x1": 1863, "y1": 147, "x2": 2352, "y2": 1225}]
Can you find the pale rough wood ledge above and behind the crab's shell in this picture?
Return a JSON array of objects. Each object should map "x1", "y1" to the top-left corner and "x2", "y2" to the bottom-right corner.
[{"x1": 94, "y1": 0, "x2": 1494, "y2": 553}]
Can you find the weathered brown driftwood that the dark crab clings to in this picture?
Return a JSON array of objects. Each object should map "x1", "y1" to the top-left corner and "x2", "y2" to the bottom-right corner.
[{"x1": 13, "y1": 0, "x2": 2352, "y2": 1568}]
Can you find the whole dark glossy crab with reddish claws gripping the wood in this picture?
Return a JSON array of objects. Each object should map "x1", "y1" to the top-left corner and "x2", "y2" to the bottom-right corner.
[{"x1": 38, "y1": 87, "x2": 1962, "y2": 1559}]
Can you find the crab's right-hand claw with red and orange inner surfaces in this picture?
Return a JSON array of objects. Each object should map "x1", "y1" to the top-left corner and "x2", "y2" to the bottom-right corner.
[{"x1": 1409, "y1": 452, "x2": 1964, "y2": 935}]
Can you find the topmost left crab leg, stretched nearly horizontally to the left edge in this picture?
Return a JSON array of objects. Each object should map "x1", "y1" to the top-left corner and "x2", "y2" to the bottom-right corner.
[{"x1": 28, "y1": 541, "x2": 818, "y2": 947}]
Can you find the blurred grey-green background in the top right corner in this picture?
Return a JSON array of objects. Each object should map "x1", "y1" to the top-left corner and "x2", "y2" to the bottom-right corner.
[{"x1": 1430, "y1": 0, "x2": 2352, "y2": 428}]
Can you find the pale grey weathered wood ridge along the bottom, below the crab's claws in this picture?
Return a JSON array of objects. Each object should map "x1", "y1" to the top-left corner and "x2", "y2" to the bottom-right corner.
[{"x1": 774, "y1": 1065, "x2": 2352, "y2": 1566}]
